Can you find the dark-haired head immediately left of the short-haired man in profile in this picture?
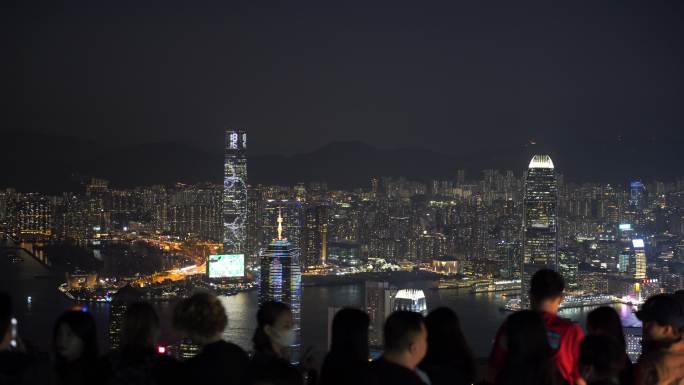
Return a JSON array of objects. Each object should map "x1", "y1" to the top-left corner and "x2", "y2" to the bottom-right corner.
[{"x1": 330, "y1": 308, "x2": 370, "y2": 361}]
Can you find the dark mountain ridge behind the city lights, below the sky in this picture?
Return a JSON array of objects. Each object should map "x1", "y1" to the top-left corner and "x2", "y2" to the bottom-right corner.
[{"x1": 0, "y1": 133, "x2": 684, "y2": 194}]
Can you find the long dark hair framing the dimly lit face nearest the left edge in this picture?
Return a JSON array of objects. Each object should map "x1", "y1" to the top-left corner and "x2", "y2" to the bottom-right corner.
[{"x1": 52, "y1": 310, "x2": 99, "y2": 370}]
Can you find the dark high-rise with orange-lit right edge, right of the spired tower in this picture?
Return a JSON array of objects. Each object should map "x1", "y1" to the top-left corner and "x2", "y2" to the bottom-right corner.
[{"x1": 302, "y1": 204, "x2": 328, "y2": 269}]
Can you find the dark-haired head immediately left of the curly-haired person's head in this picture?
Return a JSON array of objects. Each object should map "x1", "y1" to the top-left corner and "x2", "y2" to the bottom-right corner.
[{"x1": 121, "y1": 302, "x2": 160, "y2": 351}]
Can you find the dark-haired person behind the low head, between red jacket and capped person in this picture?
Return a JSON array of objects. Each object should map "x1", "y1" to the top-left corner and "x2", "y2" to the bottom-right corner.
[{"x1": 587, "y1": 306, "x2": 634, "y2": 385}]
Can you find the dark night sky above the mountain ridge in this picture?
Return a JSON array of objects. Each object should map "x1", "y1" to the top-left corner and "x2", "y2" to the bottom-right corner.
[{"x1": 0, "y1": 0, "x2": 684, "y2": 158}]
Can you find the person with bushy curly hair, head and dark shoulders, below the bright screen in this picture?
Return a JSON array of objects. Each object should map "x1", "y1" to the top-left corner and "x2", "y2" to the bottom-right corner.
[{"x1": 173, "y1": 293, "x2": 249, "y2": 385}]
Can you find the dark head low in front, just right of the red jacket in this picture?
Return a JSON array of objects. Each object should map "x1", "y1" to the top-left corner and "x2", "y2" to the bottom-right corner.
[{"x1": 579, "y1": 334, "x2": 625, "y2": 384}]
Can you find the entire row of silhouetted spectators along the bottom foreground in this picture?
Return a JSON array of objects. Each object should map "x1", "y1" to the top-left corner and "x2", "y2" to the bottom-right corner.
[{"x1": 0, "y1": 270, "x2": 684, "y2": 385}]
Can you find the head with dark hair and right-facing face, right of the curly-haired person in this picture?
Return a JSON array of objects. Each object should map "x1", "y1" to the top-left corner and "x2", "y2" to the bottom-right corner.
[{"x1": 252, "y1": 301, "x2": 295, "y2": 355}]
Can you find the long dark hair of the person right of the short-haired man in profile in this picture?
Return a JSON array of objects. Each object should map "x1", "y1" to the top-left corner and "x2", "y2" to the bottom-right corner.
[{"x1": 420, "y1": 307, "x2": 476, "y2": 381}]
